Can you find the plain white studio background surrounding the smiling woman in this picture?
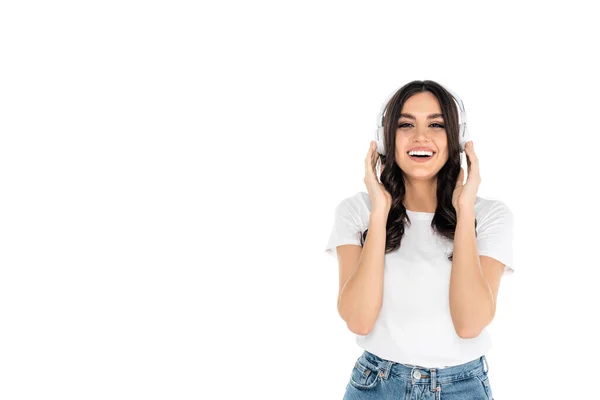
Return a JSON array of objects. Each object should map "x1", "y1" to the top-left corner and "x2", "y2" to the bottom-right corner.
[{"x1": 0, "y1": 1, "x2": 600, "y2": 400}]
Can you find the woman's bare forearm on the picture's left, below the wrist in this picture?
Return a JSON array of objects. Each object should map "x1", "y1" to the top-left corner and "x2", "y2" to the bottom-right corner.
[{"x1": 340, "y1": 213, "x2": 387, "y2": 335}]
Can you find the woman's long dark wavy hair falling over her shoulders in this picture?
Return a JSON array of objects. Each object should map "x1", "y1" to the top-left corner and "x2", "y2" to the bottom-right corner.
[{"x1": 361, "y1": 80, "x2": 477, "y2": 261}]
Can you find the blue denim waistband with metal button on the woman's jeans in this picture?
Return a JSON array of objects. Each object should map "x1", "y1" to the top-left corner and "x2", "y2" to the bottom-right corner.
[{"x1": 361, "y1": 350, "x2": 488, "y2": 389}]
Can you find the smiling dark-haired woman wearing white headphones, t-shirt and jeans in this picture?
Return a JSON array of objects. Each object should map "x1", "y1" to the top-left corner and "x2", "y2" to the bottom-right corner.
[{"x1": 326, "y1": 80, "x2": 513, "y2": 400}]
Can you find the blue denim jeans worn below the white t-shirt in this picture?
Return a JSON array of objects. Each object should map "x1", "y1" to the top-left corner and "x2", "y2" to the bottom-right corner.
[{"x1": 344, "y1": 350, "x2": 493, "y2": 400}]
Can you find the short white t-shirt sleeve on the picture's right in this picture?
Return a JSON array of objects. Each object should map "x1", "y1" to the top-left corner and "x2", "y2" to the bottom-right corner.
[{"x1": 477, "y1": 200, "x2": 514, "y2": 275}]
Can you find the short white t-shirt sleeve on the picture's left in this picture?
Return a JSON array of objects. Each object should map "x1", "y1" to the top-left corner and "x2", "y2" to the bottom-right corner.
[{"x1": 325, "y1": 199, "x2": 366, "y2": 258}]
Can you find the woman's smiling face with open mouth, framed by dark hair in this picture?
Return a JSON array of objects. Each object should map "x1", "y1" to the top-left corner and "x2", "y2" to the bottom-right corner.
[{"x1": 395, "y1": 92, "x2": 448, "y2": 180}]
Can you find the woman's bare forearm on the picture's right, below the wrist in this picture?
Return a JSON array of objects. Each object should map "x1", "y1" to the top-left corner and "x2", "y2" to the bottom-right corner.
[{"x1": 450, "y1": 207, "x2": 494, "y2": 337}]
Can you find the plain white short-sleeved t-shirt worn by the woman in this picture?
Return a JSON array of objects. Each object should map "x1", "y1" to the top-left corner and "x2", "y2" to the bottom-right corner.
[{"x1": 325, "y1": 192, "x2": 513, "y2": 368}]
